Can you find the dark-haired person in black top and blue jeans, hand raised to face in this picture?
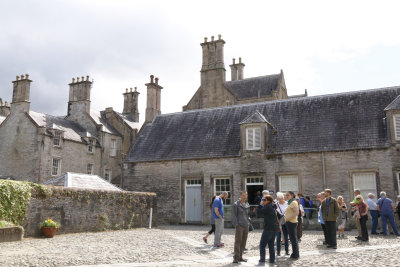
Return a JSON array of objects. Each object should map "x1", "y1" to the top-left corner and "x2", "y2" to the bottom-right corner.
[{"x1": 259, "y1": 195, "x2": 279, "y2": 263}]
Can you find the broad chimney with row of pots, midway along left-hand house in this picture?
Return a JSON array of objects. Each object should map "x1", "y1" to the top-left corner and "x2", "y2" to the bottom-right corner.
[{"x1": 68, "y1": 76, "x2": 93, "y2": 116}]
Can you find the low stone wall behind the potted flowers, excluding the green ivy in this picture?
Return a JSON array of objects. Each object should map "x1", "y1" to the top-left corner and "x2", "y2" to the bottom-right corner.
[{"x1": 23, "y1": 186, "x2": 157, "y2": 236}]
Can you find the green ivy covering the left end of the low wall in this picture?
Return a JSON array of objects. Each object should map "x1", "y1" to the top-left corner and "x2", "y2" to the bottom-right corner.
[{"x1": 0, "y1": 180, "x2": 48, "y2": 225}]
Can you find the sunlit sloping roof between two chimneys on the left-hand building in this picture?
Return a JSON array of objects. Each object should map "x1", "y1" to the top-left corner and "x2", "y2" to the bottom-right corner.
[{"x1": 28, "y1": 110, "x2": 86, "y2": 142}]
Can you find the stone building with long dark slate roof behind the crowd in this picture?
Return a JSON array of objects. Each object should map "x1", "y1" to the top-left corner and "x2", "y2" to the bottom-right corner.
[{"x1": 123, "y1": 35, "x2": 400, "y2": 223}]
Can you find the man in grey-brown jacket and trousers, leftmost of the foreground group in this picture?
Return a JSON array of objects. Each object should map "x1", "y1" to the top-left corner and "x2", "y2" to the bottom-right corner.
[{"x1": 232, "y1": 191, "x2": 250, "y2": 263}]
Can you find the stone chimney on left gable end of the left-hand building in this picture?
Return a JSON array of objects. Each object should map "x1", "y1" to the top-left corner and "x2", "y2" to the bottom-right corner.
[{"x1": 11, "y1": 74, "x2": 32, "y2": 112}]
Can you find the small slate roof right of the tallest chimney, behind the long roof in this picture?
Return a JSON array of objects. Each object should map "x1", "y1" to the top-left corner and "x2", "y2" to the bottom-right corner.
[{"x1": 225, "y1": 74, "x2": 281, "y2": 99}]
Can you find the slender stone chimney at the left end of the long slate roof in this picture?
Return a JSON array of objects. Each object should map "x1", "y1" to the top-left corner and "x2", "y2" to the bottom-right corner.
[{"x1": 145, "y1": 75, "x2": 163, "y2": 123}]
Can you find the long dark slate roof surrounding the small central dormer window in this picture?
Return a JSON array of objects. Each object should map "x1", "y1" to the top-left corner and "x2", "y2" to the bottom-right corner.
[{"x1": 127, "y1": 87, "x2": 400, "y2": 162}]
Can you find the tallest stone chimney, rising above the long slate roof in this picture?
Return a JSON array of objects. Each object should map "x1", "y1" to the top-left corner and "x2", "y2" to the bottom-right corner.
[{"x1": 200, "y1": 35, "x2": 225, "y2": 85}]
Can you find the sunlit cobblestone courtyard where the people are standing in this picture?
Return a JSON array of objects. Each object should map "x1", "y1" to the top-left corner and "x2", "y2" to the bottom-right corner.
[{"x1": 0, "y1": 226, "x2": 400, "y2": 267}]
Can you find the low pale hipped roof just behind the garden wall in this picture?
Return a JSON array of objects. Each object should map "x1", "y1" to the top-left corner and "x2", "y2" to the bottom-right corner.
[{"x1": 43, "y1": 172, "x2": 122, "y2": 191}]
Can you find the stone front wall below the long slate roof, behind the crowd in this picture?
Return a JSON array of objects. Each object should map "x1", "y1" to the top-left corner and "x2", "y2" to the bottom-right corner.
[{"x1": 124, "y1": 147, "x2": 400, "y2": 223}]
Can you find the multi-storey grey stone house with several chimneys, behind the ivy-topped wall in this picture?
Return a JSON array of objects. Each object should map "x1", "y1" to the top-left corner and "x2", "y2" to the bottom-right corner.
[{"x1": 0, "y1": 74, "x2": 159, "y2": 184}]
